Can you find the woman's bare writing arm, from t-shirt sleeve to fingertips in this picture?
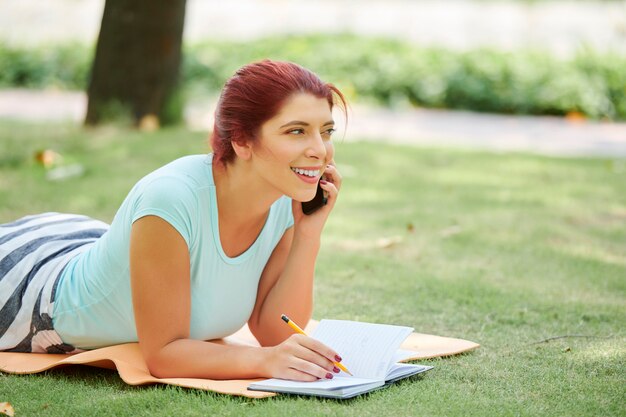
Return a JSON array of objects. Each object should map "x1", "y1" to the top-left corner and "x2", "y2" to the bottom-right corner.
[{"x1": 130, "y1": 216, "x2": 336, "y2": 381}]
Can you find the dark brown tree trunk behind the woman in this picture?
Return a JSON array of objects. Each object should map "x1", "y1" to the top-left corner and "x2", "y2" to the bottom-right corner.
[{"x1": 85, "y1": 0, "x2": 185, "y2": 125}]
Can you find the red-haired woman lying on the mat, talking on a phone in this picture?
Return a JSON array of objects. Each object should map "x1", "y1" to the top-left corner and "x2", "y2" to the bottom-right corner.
[{"x1": 0, "y1": 60, "x2": 345, "y2": 381}]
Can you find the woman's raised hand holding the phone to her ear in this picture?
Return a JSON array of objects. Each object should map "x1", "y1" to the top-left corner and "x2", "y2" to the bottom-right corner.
[{"x1": 292, "y1": 160, "x2": 342, "y2": 235}]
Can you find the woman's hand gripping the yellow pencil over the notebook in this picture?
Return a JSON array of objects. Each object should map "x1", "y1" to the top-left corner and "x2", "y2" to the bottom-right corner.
[{"x1": 266, "y1": 334, "x2": 341, "y2": 381}]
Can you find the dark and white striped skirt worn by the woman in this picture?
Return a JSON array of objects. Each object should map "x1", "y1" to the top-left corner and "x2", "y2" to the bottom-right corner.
[{"x1": 0, "y1": 213, "x2": 109, "y2": 353}]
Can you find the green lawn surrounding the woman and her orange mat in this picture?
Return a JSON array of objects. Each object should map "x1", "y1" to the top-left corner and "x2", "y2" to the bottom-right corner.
[{"x1": 0, "y1": 121, "x2": 626, "y2": 416}]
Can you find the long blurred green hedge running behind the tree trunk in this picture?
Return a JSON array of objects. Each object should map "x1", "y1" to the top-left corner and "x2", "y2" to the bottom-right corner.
[{"x1": 0, "y1": 35, "x2": 626, "y2": 120}]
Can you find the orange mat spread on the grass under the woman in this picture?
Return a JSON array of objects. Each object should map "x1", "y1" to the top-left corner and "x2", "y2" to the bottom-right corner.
[{"x1": 0, "y1": 320, "x2": 480, "y2": 398}]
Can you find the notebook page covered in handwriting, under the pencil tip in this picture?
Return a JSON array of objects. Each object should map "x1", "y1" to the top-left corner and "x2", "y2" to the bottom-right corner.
[{"x1": 311, "y1": 320, "x2": 413, "y2": 380}]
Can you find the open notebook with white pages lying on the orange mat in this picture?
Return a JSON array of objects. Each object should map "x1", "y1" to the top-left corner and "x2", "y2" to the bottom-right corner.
[{"x1": 248, "y1": 320, "x2": 432, "y2": 398}]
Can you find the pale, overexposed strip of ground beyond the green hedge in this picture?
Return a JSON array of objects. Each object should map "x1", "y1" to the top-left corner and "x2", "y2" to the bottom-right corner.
[{"x1": 0, "y1": 0, "x2": 626, "y2": 53}]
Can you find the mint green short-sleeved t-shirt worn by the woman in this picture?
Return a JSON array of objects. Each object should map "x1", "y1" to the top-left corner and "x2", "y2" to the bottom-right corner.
[{"x1": 53, "y1": 154, "x2": 293, "y2": 349}]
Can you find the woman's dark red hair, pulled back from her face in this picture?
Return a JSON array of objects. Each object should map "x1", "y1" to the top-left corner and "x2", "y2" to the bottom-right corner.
[{"x1": 211, "y1": 59, "x2": 346, "y2": 164}]
